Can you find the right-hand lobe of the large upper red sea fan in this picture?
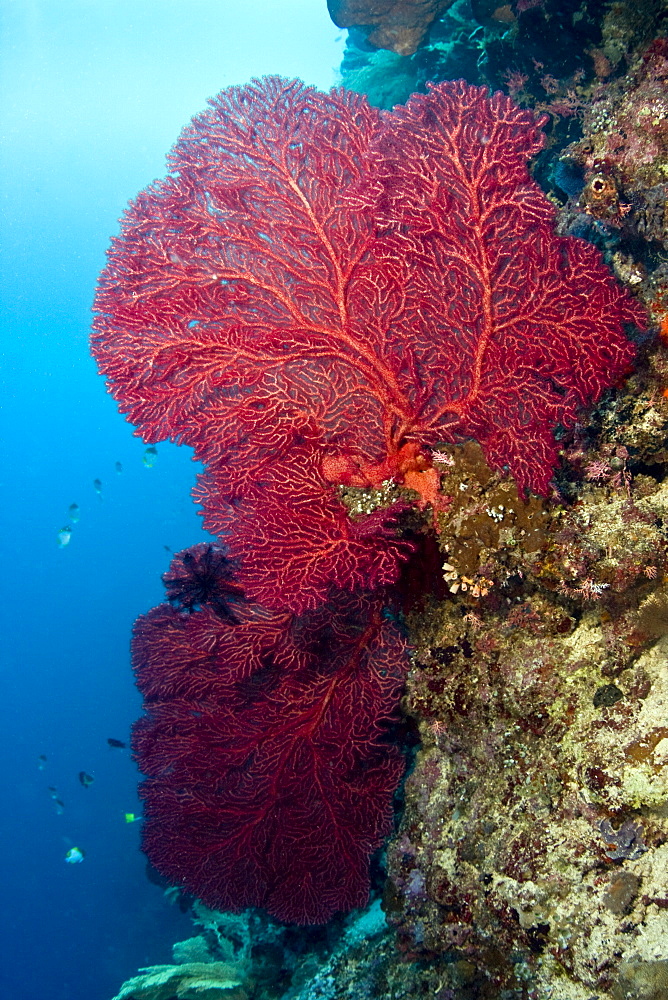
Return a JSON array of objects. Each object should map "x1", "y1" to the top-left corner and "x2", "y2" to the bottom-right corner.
[{"x1": 363, "y1": 81, "x2": 646, "y2": 494}]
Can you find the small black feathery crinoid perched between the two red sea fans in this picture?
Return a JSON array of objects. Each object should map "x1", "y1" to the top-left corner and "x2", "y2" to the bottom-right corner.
[{"x1": 162, "y1": 542, "x2": 244, "y2": 624}]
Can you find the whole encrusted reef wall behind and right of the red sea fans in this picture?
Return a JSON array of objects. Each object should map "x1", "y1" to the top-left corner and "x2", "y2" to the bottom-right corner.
[{"x1": 328, "y1": 0, "x2": 668, "y2": 1000}]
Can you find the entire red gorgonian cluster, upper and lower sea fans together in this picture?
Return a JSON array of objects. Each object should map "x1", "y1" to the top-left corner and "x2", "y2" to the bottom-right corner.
[{"x1": 93, "y1": 78, "x2": 642, "y2": 922}]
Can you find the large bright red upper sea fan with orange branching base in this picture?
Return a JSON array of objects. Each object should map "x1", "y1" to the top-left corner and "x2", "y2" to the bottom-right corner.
[{"x1": 93, "y1": 78, "x2": 641, "y2": 611}]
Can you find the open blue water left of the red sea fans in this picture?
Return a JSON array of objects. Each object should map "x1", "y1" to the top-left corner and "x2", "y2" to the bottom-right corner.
[{"x1": 0, "y1": 0, "x2": 343, "y2": 1000}]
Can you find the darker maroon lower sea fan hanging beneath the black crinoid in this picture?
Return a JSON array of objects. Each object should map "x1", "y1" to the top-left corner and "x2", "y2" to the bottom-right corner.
[{"x1": 133, "y1": 594, "x2": 406, "y2": 923}]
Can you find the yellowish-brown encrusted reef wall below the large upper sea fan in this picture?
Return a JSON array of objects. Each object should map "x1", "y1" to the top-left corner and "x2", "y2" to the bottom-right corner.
[{"x1": 385, "y1": 378, "x2": 668, "y2": 1000}]
